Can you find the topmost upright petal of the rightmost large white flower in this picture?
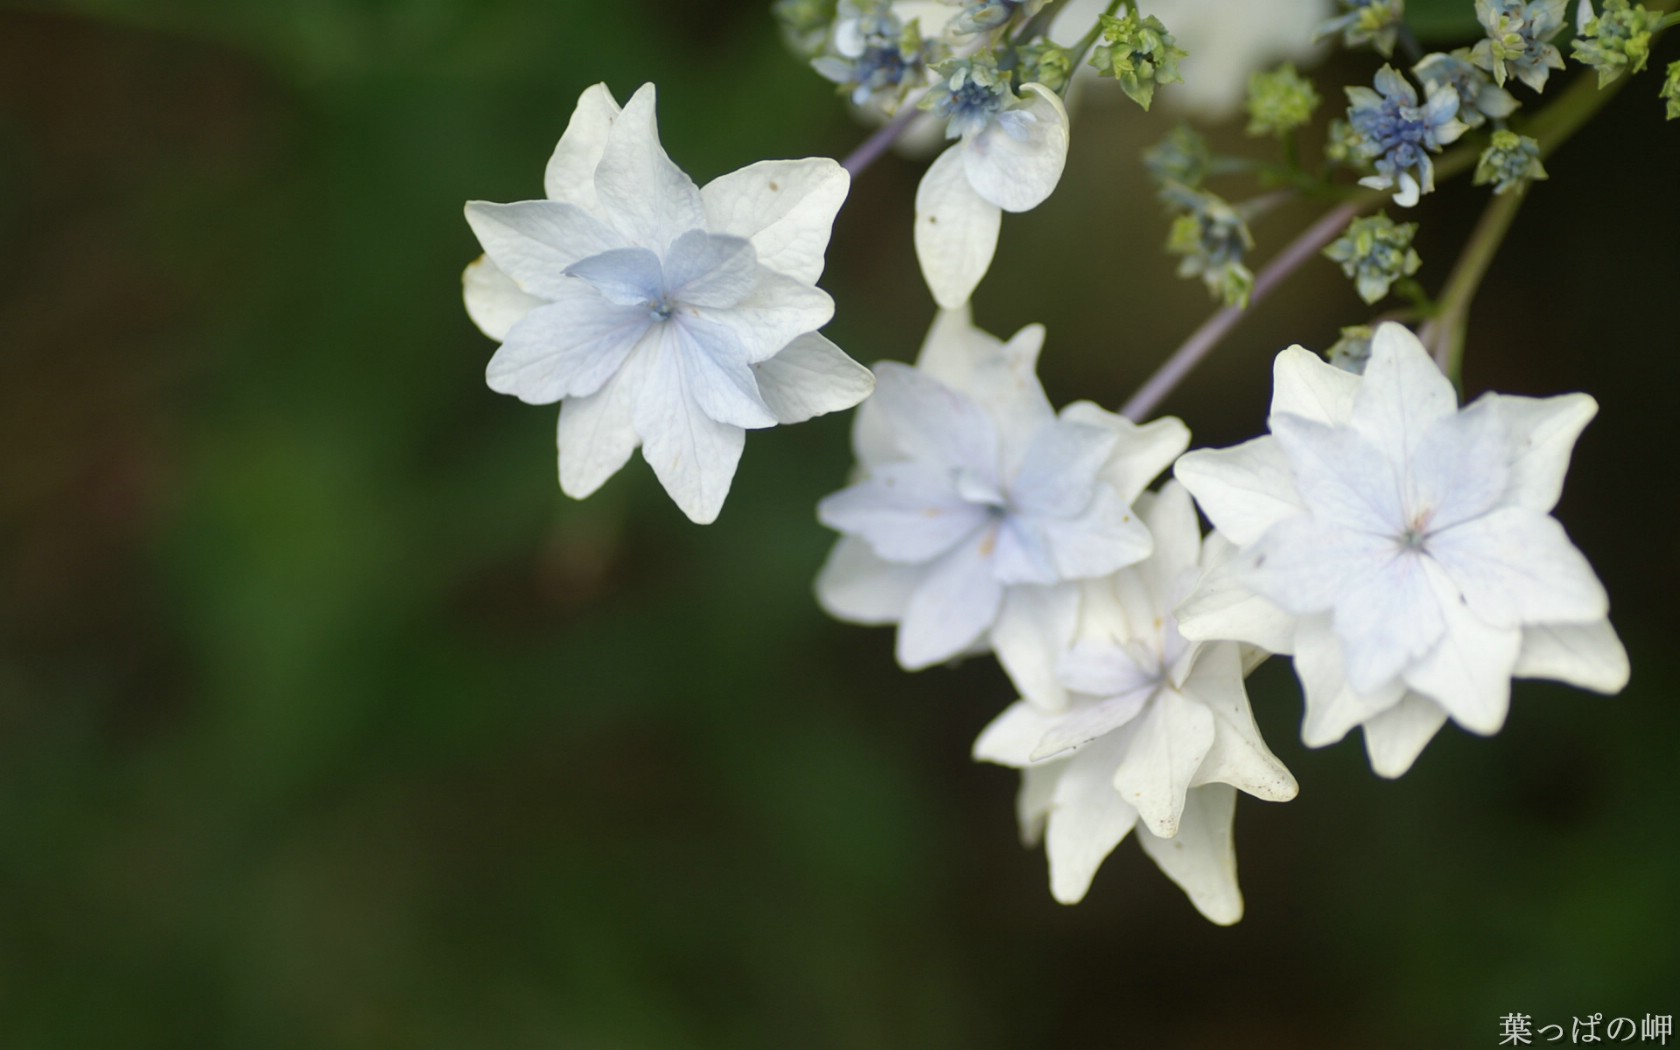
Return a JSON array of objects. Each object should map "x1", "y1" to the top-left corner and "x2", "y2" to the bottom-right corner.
[{"x1": 1351, "y1": 321, "x2": 1458, "y2": 462}]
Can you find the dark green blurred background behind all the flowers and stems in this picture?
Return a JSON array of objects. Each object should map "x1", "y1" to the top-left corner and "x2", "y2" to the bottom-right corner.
[{"x1": 0, "y1": 0, "x2": 1680, "y2": 1048}]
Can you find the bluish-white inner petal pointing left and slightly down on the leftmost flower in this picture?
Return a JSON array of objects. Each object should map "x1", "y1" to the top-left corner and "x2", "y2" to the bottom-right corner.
[{"x1": 486, "y1": 281, "x2": 659, "y2": 405}]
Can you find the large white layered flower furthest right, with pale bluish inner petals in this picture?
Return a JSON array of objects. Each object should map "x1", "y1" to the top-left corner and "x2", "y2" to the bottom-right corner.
[{"x1": 1176, "y1": 324, "x2": 1628, "y2": 776}]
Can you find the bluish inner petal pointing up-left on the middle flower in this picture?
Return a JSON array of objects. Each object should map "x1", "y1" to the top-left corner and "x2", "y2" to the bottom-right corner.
[{"x1": 869, "y1": 361, "x2": 998, "y2": 474}]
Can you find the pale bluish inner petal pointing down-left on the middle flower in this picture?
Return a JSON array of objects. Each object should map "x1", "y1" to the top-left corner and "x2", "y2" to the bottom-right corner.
[{"x1": 897, "y1": 533, "x2": 1003, "y2": 670}]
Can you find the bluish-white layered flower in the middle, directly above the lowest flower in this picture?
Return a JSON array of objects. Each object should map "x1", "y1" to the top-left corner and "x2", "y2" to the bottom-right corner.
[{"x1": 816, "y1": 311, "x2": 1189, "y2": 707}]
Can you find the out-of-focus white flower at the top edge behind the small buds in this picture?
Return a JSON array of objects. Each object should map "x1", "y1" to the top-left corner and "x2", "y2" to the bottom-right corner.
[{"x1": 1050, "y1": 0, "x2": 1331, "y2": 119}]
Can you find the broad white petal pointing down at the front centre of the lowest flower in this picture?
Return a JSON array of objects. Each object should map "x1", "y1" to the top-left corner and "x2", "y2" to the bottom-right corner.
[{"x1": 1114, "y1": 689, "x2": 1213, "y2": 838}]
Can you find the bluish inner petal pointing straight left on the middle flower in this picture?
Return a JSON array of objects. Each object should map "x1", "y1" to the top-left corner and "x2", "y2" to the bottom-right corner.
[{"x1": 816, "y1": 462, "x2": 991, "y2": 563}]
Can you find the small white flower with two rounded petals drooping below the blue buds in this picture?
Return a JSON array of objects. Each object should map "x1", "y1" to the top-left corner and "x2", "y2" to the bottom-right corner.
[{"x1": 916, "y1": 84, "x2": 1067, "y2": 309}]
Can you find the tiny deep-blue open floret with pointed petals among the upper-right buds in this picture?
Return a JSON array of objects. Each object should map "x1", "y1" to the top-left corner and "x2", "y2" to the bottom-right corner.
[{"x1": 1347, "y1": 66, "x2": 1465, "y2": 208}]
